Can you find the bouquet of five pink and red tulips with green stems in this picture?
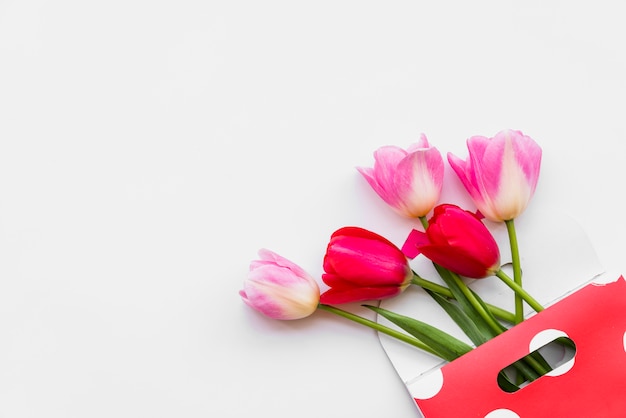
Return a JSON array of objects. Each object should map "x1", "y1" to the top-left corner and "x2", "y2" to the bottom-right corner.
[{"x1": 240, "y1": 130, "x2": 556, "y2": 392}]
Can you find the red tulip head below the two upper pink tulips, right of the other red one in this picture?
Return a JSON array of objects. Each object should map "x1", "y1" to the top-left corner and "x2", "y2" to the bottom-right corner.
[{"x1": 402, "y1": 204, "x2": 500, "y2": 279}]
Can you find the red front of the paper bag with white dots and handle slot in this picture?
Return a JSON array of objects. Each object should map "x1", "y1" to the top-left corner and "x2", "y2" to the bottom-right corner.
[{"x1": 415, "y1": 277, "x2": 626, "y2": 418}]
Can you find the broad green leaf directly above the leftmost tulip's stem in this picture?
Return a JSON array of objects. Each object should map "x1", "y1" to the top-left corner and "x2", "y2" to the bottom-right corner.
[{"x1": 363, "y1": 305, "x2": 472, "y2": 361}]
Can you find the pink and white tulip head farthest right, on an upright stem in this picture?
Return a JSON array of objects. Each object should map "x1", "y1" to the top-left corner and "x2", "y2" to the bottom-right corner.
[{"x1": 448, "y1": 130, "x2": 541, "y2": 222}]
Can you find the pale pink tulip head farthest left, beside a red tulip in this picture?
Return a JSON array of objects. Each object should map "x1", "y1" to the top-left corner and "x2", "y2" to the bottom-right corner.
[{"x1": 239, "y1": 250, "x2": 320, "y2": 319}]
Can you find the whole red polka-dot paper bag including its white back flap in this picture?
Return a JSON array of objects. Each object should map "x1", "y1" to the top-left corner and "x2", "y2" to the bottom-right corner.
[{"x1": 377, "y1": 210, "x2": 608, "y2": 418}]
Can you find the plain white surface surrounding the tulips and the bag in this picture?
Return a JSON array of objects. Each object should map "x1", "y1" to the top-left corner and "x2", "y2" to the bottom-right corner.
[{"x1": 0, "y1": 0, "x2": 626, "y2": 418}]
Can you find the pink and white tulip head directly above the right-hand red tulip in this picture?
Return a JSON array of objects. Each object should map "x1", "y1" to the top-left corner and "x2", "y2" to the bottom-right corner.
[{"x1": 357, "y1": 134, "x2": 443, "y2": 218}]
